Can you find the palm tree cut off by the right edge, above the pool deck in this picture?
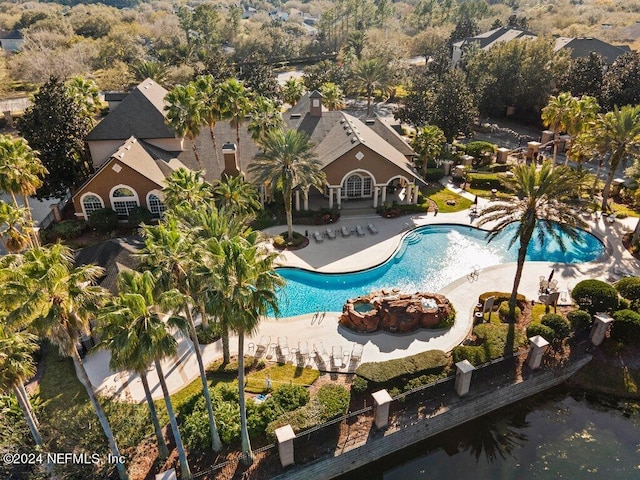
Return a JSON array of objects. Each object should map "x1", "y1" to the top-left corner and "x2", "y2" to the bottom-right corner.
[{"x1": 578, "y1": 105, "x2": 640, "y2": 211}]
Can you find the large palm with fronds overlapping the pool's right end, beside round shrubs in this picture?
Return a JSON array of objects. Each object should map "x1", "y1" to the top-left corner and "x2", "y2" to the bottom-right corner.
[{"x1": 478, "y1": 161, "x2": 584, "y2": 316}]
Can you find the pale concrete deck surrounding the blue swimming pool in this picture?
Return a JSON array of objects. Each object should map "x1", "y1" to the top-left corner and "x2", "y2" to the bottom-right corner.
[{"x1": 85, "y1": 186, "x2": 640, "y2": 402}]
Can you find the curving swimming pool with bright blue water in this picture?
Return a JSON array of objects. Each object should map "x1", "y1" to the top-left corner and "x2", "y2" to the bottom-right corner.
[{"x1": 277, "y1": 225, "x2": 604, "y2": 317}]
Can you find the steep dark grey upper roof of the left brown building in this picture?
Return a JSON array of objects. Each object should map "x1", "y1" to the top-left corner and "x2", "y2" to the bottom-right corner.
[{"x1": 86, "y1": 78, "x2": 176, "y2": 141}]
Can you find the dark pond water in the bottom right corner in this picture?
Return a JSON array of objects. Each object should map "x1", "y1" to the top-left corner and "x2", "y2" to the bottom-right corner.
[{"x1": 340, "y1": 387, "x2": 640, "y2": 480}]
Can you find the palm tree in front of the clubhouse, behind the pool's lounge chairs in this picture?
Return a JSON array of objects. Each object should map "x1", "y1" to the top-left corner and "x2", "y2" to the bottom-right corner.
[{"x1": 249, "y1": 129, "x2": 326, "y2": 240}]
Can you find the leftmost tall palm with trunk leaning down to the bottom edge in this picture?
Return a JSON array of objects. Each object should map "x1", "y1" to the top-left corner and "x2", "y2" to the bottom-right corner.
[{"x1": 3, "y1": 244, "x2": 129, "y2": 480}]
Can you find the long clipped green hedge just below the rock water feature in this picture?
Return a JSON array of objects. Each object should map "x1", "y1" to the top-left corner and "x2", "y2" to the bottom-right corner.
[{"x1": 356, "y1": 350, "x2": 448, "y2": 384}]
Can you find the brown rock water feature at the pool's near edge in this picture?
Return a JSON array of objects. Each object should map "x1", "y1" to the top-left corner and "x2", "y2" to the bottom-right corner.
[{"x1": 340, "y1": 289, "x2": 455, "y2": 333}]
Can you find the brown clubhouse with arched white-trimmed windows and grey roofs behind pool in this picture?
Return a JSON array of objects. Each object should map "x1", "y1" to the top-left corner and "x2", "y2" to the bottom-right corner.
[{"x1": 73, "y1": 79, "x2": 423, "y2": 220}]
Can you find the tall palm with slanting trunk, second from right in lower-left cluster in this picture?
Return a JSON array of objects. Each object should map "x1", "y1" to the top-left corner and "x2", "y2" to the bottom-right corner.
[{"x1": 143, "y1": 219, "x2": 222, "y2": 452}]
